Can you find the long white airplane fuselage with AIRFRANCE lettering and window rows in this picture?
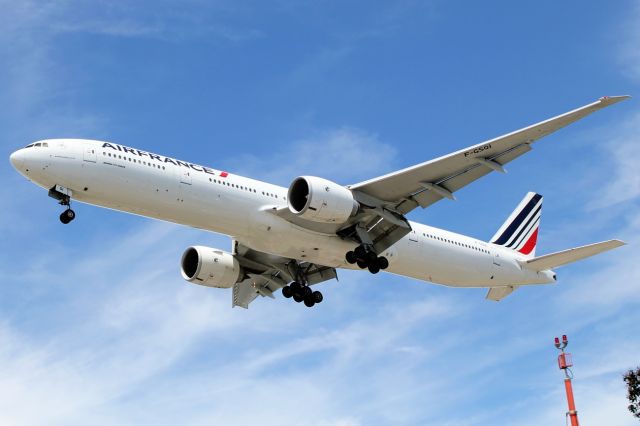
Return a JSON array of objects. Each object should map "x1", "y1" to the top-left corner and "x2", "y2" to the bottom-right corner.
[{"x1": 12, "y1": 139, "x2": 554, "y2": 287}]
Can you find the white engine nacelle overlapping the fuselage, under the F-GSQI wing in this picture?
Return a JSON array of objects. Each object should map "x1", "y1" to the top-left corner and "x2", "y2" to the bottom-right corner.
[{"x1": 287, "y1": 176, "x2": 359, "y2": 223}]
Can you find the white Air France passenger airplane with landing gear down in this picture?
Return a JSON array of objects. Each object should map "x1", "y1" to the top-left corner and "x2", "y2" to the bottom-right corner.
[{"x1": 10, "y1": 96, "x2": 629, "y2": 308}]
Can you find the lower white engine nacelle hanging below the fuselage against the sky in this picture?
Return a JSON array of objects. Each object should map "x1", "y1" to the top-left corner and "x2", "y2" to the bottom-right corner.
[{"x1": 180, "y1": 246, "x2": 242, "y2": 288}]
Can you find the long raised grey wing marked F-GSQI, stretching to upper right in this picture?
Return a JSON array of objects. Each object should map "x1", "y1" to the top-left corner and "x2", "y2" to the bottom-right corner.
[{"x1": 350, "y1": 96, "x2": 629, "y2": 215}]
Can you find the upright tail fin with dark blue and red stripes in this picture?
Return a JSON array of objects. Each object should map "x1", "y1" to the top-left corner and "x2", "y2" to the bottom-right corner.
[{"x1": 491, "y1": 192, "x2": 542, "y2": 258}]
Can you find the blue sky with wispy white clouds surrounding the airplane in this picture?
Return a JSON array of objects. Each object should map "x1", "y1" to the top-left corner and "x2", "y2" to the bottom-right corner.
[{"x1": 0, "y1": 0, "x2": 640, "y2": 426}]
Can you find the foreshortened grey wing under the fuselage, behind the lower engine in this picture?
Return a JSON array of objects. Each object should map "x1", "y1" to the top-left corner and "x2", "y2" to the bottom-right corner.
[{"x1": 232, "y1": 241, "x2": 337, "y2": 309}]
